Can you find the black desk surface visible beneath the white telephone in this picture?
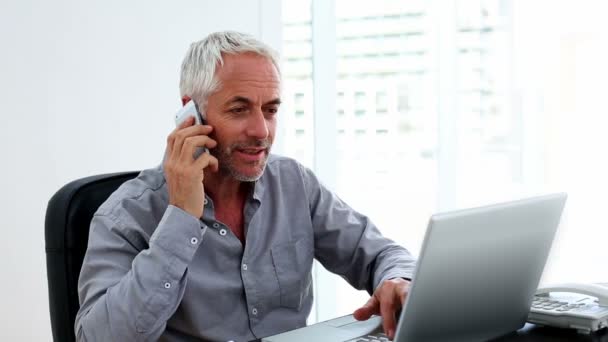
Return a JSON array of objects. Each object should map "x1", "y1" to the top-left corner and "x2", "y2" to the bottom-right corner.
[{"x1": 251, "y1": 323, "x2": 608, "y2": 342}]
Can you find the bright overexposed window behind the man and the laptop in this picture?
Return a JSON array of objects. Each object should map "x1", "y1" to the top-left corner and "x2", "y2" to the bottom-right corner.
[{"x1": 283, "y1": 0, "x2": 608, "y2": 321}]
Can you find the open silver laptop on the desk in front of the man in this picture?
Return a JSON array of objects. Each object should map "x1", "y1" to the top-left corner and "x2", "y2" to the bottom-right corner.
[{"x1": 262, "y1": 193, "x2": 566, "y2": 342}]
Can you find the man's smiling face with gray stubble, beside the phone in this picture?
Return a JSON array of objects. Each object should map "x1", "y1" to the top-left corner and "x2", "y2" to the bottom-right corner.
[{"x1": 206, "y1": 53, "x2": 280, "y2": 182}]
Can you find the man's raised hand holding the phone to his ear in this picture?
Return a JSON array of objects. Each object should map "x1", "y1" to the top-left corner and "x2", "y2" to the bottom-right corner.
[{"x1": 163, "y1": 118, "x2": 218, "y2": 219}]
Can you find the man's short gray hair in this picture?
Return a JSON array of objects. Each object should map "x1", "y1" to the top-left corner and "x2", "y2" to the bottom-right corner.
[{"x1": 179, "y1": 31, "x2": 281, "y2": 109}]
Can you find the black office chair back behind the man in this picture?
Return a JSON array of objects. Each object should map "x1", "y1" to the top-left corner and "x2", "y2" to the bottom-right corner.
[{"x1": 44, "y1": 172, "x2": 139, "y2": 341}]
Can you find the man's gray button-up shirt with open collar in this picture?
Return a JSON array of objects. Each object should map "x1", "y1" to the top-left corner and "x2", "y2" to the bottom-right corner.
[{"x1": 75, "y1": 156, "x2": 415, "y2": 341}]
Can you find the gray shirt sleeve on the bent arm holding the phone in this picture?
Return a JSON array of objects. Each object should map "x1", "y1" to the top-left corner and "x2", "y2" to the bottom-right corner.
[{"x1": 75, "y1": 205, "x2": 206, "y2": 341}]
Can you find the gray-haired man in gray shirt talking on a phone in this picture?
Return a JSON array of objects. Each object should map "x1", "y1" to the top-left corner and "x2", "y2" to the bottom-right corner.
[{"x1": 75, "y1": 32, "x2": 415, "y2": 341}]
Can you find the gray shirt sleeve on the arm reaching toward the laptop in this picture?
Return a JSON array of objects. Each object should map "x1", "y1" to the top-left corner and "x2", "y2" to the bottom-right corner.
[{"x1": 302, "y1": 168, "x2": 416, "y2": 294}]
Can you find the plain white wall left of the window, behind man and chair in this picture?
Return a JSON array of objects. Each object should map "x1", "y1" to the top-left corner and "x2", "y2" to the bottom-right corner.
[{"x1": 0, "y1": 0, "x2": 281, "y2": 341}]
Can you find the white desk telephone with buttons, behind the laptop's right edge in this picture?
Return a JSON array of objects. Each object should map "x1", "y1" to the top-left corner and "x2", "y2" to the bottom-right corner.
[{"x1": 528, "y1": 283, "x2": 608, "y2": 334}]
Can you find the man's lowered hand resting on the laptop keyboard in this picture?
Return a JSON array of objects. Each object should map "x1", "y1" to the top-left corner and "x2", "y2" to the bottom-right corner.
[{"x1": 353, "y1": 278, "x2": 410, "y2": 340}]
